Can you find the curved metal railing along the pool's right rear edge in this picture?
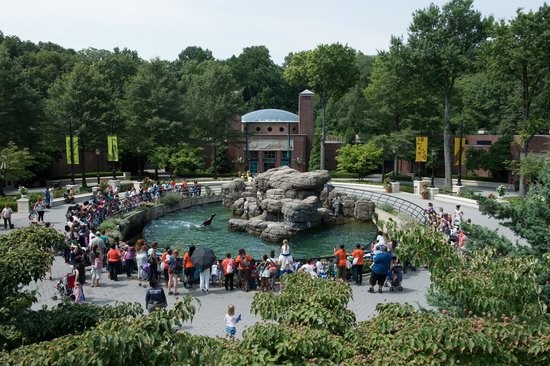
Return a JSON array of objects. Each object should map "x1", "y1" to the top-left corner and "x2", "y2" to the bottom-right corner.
[{"x1": 334, "y1": 183, "x2": 426, "y2": 224}]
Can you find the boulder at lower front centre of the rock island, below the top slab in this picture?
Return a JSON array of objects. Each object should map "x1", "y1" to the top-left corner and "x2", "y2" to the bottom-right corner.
[{"x1": 281, "y1": 196, "x2": 321, "y2": 230}]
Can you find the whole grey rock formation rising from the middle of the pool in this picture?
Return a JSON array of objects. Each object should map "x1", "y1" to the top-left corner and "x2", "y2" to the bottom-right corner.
[{"x1": 222, "y1": 166, "x2": 374, "y2": 241}]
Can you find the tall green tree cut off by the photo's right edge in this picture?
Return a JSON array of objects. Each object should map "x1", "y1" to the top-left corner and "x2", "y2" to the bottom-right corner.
[{"x1": 489, "y1": 3, "x2": 550, "y2": 195}]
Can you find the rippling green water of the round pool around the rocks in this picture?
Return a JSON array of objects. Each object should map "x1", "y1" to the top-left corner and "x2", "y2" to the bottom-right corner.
[{"x1": 143, "y1": 203, "x2": 376, "y2": 258}]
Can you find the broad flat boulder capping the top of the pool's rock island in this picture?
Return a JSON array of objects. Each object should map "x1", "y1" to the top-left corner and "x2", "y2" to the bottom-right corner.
[{"x1": 254, "y1": 166, "x2": 330, "y2": 198}]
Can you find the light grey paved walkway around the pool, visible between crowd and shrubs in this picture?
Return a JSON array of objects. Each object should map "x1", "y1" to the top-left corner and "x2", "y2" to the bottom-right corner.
[{"x1": 5, "y1": 181, "x2": 513, "y2": 337}]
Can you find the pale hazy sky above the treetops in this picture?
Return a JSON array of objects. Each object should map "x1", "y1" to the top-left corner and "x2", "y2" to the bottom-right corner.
[{"x1": 0, "y1": 0, "x2": 544, "y2": 64}]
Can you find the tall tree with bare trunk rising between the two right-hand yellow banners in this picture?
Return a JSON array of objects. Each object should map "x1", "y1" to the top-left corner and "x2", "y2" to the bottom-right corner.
[{"x1": 408, "y1": 0, "x2": 491, "y2": 186}]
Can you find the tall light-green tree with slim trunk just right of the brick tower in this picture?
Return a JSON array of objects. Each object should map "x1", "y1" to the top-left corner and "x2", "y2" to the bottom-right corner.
[{"x1": 284, "y1": 43, "x2": 358, "y2": 169}]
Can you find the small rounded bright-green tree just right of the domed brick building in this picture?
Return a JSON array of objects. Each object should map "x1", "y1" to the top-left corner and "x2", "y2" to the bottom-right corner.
[{"x1": 336, "y1": 143, "x2": 383, "y2": 178}]
